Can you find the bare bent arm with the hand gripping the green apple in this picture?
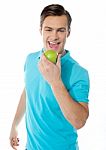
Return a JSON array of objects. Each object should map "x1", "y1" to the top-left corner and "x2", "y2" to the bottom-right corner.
[{"x1": 39, "y1": 55, "x2": 89, "y2": 129}]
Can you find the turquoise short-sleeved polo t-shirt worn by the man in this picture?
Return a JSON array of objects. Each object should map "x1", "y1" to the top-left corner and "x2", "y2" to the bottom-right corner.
[{"x1": 25, "y1": 51, "x2": 89, "y2": 150}]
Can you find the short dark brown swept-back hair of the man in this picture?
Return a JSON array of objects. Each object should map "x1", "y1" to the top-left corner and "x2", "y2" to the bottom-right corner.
[{"x1": 40, "y1": 4, "x2": 72, "y2": 30}]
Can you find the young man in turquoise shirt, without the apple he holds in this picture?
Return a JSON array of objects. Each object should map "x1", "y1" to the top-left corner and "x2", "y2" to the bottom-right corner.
[{"x1": 10, "y1": 4, "x2": 89, "y2": 150}]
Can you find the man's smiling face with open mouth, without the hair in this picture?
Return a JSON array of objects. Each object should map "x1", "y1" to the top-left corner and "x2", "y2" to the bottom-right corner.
[{"x1": 41, "y1": 15, "x2": 69, "y2": 53}]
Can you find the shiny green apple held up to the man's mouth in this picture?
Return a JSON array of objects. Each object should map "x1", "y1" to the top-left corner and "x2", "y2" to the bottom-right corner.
[{"x1": 44, "y1": 49, "x2": 58, "y2": 64}]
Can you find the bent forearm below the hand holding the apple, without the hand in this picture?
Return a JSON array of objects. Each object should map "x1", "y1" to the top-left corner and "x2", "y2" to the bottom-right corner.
[{"x1": 52, "y1": 80, "x2": 88, "y2": 129}]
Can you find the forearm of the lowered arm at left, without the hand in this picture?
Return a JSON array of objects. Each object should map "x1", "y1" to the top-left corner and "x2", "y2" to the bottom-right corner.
[{"x1": 12, "y1": 90, "x2": 26, "y2": 127}]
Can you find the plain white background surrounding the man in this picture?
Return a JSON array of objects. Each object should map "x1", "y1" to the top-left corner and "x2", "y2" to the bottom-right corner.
[{"x1": 0, "y1": 0, "x2": 106, "y2": 150}]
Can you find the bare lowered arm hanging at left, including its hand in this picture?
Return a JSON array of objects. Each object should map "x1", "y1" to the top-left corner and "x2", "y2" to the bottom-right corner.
[{"x1": 10, "y1": 89, "x2": 26, "y2": 150}]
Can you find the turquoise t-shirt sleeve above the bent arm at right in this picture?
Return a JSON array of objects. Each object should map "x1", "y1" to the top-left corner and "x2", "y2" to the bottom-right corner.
[{"x1": 69, "y1": 66, "x2": 90, "y2": 103}]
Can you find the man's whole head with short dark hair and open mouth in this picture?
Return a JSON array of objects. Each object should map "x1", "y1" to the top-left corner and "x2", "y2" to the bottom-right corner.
[{"x1": 40, "y1": 4, "x2": 72, "y2": 53}]
